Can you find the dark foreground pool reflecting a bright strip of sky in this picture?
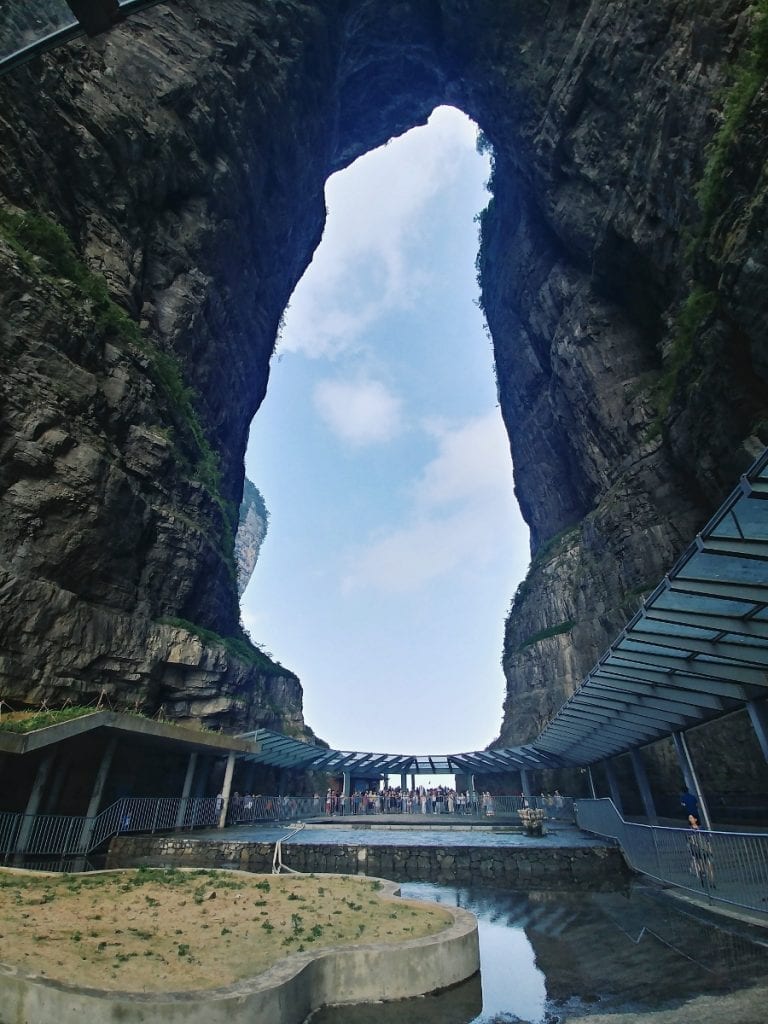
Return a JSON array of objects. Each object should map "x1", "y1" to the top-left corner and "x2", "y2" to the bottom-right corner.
[{"x1": 309, "y1": 883, "x2": 768, "y2": 1024}]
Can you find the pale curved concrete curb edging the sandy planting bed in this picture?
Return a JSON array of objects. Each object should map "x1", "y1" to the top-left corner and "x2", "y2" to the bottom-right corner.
[{"x1": 0, "y1": 871, "x2": 480, "y2": 1024}]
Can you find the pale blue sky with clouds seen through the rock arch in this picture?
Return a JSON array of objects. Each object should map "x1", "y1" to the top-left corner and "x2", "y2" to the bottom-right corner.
[{"x1": 242, "y1": 108, "x2": 528, "y2": 753}]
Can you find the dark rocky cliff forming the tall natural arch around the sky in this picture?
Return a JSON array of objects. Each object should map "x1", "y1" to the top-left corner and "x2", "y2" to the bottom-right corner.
[{"x1": 0, "y1": 0, "x2": 768, "y2": 742}]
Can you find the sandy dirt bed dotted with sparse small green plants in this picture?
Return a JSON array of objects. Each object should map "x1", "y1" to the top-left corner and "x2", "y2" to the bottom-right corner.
[{"x1": 0, "y1": 868, "x2": 453, "y2": 992}]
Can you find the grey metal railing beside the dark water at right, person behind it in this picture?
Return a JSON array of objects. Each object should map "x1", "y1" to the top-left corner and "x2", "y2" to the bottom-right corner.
[{"x1": 577, "y1": 799, "x2": 768, "y2": 912}]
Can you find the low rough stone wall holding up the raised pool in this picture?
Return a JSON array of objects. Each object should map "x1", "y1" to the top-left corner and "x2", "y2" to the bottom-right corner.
[{"x1": 106, "y1": 835, "x2": 629, "y2": 888}]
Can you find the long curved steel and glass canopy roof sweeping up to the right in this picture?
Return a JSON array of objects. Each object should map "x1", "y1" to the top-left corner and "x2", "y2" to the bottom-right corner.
[{"x1": 237, "y1": 449, "x2": 768, "y2": 778}]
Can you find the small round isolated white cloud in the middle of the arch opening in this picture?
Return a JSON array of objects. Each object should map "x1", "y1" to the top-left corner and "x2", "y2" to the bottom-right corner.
[{"x1": 314, "y1": 378, "x2": 402, "y2": 446}]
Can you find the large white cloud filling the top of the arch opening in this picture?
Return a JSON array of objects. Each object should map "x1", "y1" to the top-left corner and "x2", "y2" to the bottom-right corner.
[{"x1": 281, "y1": 108, "x2": 489, "y2": 357}]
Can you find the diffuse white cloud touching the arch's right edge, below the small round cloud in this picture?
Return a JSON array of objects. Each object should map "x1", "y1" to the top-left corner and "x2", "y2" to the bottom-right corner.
[{"x1": 342, "y1": 411, "x2": 527, "y2": 593}]
